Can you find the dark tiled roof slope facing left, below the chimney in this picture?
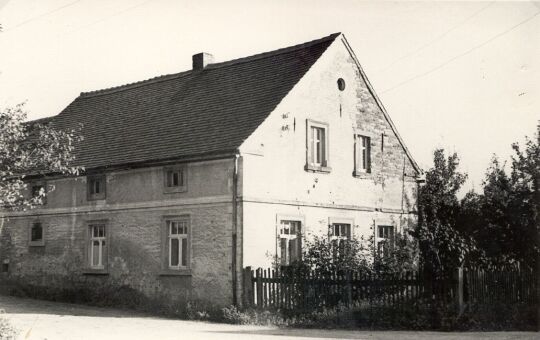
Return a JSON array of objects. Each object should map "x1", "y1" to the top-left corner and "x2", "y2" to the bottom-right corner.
[{"x1": 47, "y1": 33, "x2": 339, "y2": 168}]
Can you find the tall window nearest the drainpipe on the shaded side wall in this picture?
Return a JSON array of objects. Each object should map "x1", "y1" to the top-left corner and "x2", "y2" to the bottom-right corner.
[{"x1": 167, "y1": 220, "x2": 189, "y2": 269}]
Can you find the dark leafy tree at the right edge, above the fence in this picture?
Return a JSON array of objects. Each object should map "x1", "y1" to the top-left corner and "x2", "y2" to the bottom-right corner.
[{"x1": 458, "y1": 126, "x2": 540, "y2": 268}]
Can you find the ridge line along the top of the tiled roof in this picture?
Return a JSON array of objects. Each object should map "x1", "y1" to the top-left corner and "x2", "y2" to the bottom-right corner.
[{"x1": 79, "y1": 32, "x2": 341, "y2": 98}]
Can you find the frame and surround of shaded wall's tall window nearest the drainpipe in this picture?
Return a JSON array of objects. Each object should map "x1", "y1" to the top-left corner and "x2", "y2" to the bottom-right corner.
[{"x1": 160, "y1": 214, "x2": 193, "y2": 276}]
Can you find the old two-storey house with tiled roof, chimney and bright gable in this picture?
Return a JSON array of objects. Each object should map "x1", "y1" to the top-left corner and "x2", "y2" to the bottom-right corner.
[{"x1": 0, "y1": 33, "x2": 420, "y2": 305}]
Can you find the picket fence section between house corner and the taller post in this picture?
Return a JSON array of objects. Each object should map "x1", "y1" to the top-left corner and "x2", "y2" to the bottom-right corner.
[{"x1": 243, "y1": 267, "x2": 458, "y2": 310}]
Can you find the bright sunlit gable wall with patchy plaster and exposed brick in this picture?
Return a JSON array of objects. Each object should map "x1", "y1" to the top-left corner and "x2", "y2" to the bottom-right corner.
[{"x1": 241, "y1": 35, "x2": 417, "y2": 265}]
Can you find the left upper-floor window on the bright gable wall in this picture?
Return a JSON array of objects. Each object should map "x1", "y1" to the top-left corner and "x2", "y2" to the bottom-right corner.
[{"x1": 306, "y1": 120, "x2": 331, "y2": 172}]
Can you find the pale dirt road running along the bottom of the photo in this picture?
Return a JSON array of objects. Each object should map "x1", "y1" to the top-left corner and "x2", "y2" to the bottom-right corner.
[{"x1": 0, "y1": 295, "x2": 540, "y2": 340}]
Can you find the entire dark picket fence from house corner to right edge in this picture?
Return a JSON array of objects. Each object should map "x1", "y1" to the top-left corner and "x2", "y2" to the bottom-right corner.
[{"x1": 243, "y1": 267, "x2": 538, "y2": 312}]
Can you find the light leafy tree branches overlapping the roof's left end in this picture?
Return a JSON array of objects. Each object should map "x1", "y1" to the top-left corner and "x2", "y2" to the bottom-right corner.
[{"x1": 0, "y1": 104, "x2": 81, "y2": 210}]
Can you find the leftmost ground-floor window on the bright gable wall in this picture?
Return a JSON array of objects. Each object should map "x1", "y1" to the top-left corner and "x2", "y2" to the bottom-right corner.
[{"x1": 279, "y1": 220, "x2": 302, "y2": 266}]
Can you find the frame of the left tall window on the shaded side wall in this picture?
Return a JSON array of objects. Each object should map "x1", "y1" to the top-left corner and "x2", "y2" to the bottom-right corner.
[{"x1": 85, "y1": 219, "x2": 108, "y2": 274}]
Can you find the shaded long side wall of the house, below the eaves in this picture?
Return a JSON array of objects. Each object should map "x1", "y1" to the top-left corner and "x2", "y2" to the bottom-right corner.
[{"x1": 0, "y1": 160, "x2": 233, "y2": 305}]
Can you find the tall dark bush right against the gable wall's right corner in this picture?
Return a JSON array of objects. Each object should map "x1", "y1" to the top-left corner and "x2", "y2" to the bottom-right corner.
[{"x1": 413, "y1": 149, "x2": 475, "y2": 272}]
